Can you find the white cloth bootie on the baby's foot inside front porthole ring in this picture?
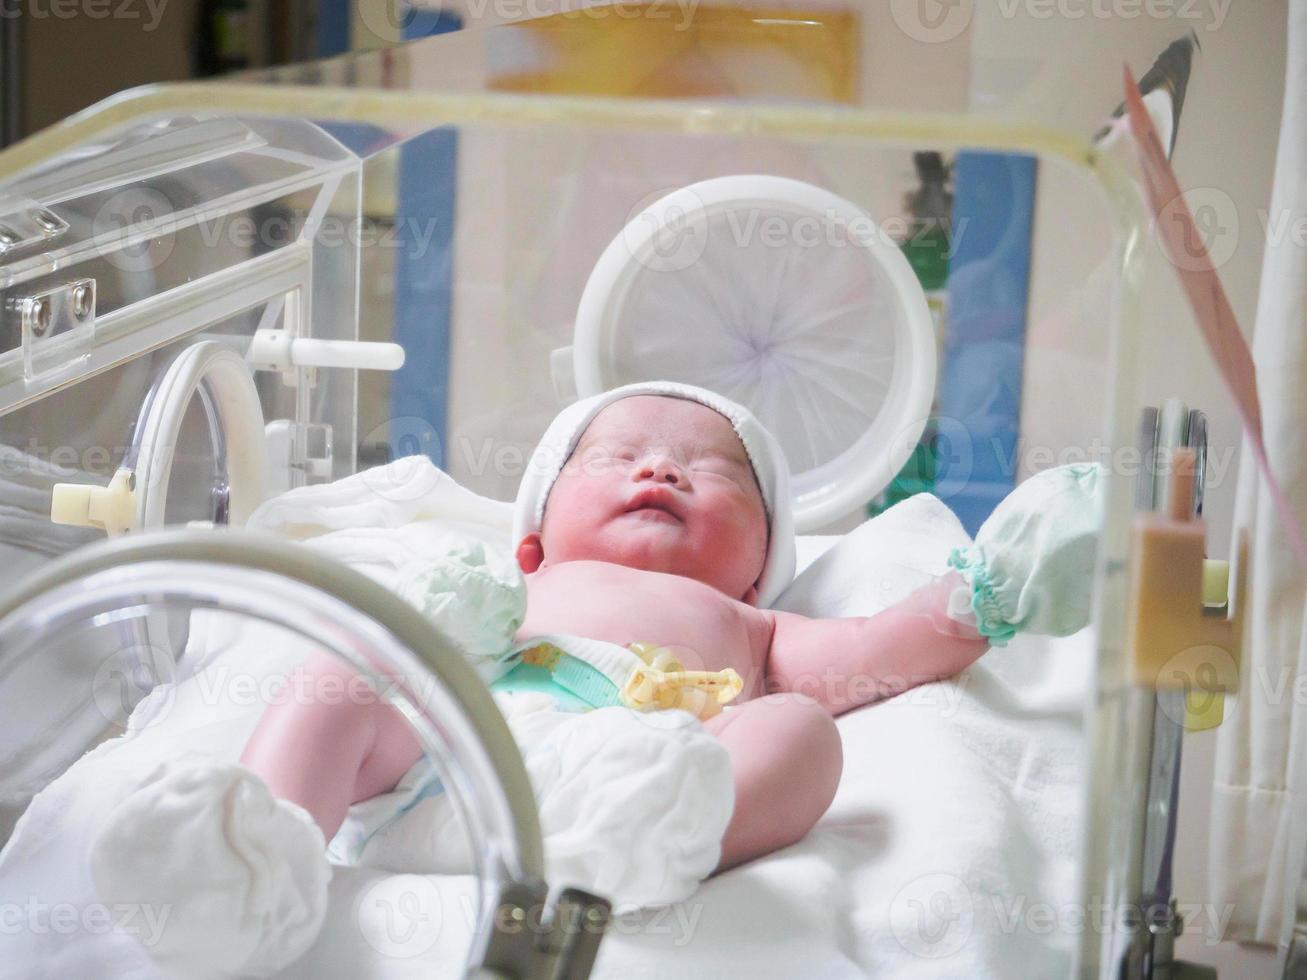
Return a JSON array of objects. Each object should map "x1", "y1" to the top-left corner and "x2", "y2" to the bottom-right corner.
[{"x1": 90, "y1": 757, "x2": 331, "y2": 980}]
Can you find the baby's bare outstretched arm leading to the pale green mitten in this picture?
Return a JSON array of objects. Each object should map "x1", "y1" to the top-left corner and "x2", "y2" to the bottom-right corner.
[{"x1": 767, "y1": 576, "x2": 988, "y2": 715}]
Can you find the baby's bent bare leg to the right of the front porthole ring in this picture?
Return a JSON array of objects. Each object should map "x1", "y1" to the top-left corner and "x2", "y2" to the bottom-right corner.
[{"x1": 704, "y1": 694, "x2": 844, "y2": 872}]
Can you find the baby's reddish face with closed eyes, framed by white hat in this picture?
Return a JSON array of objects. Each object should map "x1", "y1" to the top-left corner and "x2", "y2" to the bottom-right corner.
[{"x1": 519, "y1": 395, "x2": 767, "y2": 602}]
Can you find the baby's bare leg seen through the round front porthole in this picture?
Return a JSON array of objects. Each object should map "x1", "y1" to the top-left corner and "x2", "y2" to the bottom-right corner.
[{"x1": 240, "y1": 655, "x2": 422, "y2": 840}]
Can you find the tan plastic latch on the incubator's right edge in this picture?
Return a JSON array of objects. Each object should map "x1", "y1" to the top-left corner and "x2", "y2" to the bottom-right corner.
[{"x1": 1127, "y1": 448, "x2": 1248, "y2": 728}]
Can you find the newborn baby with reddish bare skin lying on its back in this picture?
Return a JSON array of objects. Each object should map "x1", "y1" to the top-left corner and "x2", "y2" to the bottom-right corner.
[{"x1": 242, "y1": 385, "x2": 987, "y2": 870}]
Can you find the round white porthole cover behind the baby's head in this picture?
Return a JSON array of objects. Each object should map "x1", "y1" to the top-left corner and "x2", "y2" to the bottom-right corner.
[{"x1": 572, "y1": 175, "x2": 936, "y2": 532}]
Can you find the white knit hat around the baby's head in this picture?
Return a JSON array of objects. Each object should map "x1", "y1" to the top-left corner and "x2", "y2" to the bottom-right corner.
[{"x1": 512, "y1": 382, "x2": 795, "y2": 606}]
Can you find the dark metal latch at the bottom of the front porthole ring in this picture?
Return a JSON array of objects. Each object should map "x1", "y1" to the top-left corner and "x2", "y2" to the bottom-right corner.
[{"x1": 473, "y1": 882, "x2": 612, "y2": 980}]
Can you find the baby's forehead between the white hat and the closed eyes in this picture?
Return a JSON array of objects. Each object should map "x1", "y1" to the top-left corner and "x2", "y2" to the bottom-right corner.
[{"x1": 578, "y1": 395, "x2": 749, "y2": 461}]
